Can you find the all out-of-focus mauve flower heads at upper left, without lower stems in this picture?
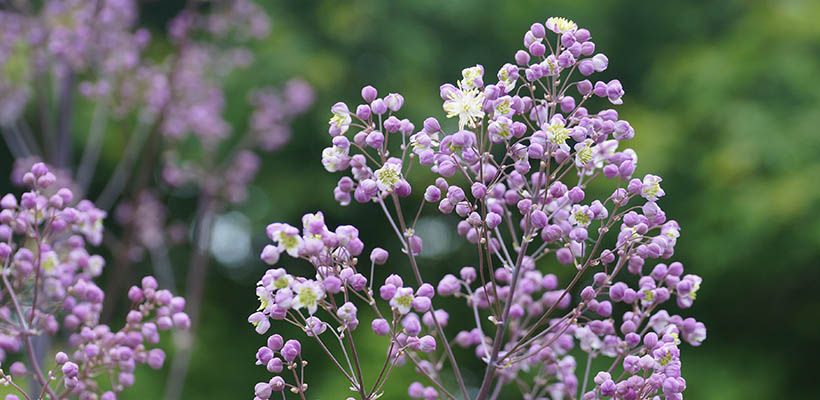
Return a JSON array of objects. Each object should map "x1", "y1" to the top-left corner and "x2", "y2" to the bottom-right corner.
[{"x1": 0, "y1": 0, "x2": 313, "y2": 208}]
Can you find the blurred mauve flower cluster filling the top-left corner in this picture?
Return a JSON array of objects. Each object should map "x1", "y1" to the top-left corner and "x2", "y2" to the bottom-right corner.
[{"x1": 0, "y1": 0, "x2": 150, "y2": 119}]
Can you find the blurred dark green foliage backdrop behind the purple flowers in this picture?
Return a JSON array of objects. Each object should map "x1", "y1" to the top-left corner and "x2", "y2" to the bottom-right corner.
[{"x1": 0, "y1": 0, "x2": 820, "y2": 400}]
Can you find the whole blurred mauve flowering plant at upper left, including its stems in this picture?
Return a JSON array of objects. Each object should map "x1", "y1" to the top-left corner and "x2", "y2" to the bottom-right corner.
[{"x1": 0, "y1": 0, "x2": 313, "y2": 399}]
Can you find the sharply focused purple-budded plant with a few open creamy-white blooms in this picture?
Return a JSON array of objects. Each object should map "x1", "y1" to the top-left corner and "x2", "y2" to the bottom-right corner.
[{"x1": 249, "y1": 18, "x2": 706, "y2": 400}]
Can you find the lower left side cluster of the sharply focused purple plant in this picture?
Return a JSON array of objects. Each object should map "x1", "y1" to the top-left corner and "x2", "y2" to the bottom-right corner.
[{"x1": 248, "y1": 212, "x2": 462, "y2": 399}]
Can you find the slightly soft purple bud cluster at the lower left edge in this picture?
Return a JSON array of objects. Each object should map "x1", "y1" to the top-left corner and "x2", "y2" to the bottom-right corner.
[{"x1": 0, "y1": 163, "x2": 190, "y2": 400}]
